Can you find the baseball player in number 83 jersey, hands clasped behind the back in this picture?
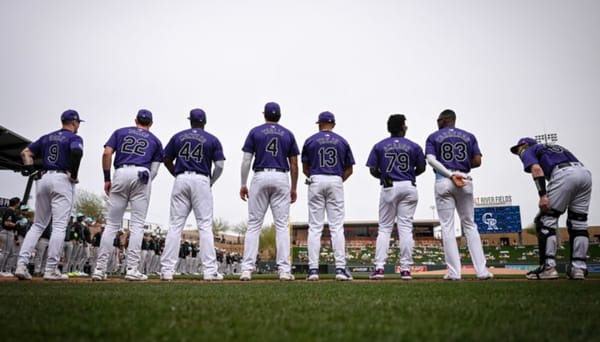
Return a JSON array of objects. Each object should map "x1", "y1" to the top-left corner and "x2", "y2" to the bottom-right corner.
[{"x1": 425, "y1": 109, "x2": 493, "y2": 280}]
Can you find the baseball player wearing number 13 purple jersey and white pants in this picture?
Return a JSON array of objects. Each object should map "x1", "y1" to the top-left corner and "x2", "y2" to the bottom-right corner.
[{"x1": 302, "y1": 112, "x2": 354, "y2": 281}]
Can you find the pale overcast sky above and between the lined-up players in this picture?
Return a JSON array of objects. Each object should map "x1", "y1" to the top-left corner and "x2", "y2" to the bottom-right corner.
[{"x1": 0, "y1": 0, "x2": 600, "y2": 230}]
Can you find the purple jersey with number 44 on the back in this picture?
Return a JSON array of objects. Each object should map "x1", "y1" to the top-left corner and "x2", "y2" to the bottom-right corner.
[{"x1": 164, "y1": 128, "x2": 225, "y2": 176}]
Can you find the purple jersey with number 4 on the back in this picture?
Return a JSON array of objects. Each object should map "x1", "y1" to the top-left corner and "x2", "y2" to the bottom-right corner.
[{"x1": 242, "y1": 123, "x2": 300, "y2": 171}]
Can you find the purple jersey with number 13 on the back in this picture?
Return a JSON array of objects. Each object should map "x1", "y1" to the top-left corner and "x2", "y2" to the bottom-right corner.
[{"x1": 302, "y1": 131, "x2": 354, "y2": 177}]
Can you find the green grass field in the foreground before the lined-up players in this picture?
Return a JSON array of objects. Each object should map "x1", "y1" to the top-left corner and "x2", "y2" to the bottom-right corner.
[{"x1": 0, "y1": 276, "x2": 600, "y2": 341}]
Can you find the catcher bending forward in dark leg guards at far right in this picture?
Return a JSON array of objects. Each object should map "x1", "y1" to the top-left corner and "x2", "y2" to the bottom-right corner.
[{"x1": 510, "y1": 138, "x2": 592, "y2": 280}]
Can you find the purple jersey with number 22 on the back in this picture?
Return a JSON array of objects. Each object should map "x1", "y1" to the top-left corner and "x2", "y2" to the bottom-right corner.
[{"x1": 104, "y1": 127, "x2": 163, "y2": 169}]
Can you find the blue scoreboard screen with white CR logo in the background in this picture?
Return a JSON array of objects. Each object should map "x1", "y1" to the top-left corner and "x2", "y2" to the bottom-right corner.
[{"x1": 475, "y1": 205, "x2": 521, "y2": 234}]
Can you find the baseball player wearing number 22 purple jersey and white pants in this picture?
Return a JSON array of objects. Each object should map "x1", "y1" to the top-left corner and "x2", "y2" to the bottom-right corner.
[{"x1": 92, "y1": 109, "x2": 162, "y2": 281}]
